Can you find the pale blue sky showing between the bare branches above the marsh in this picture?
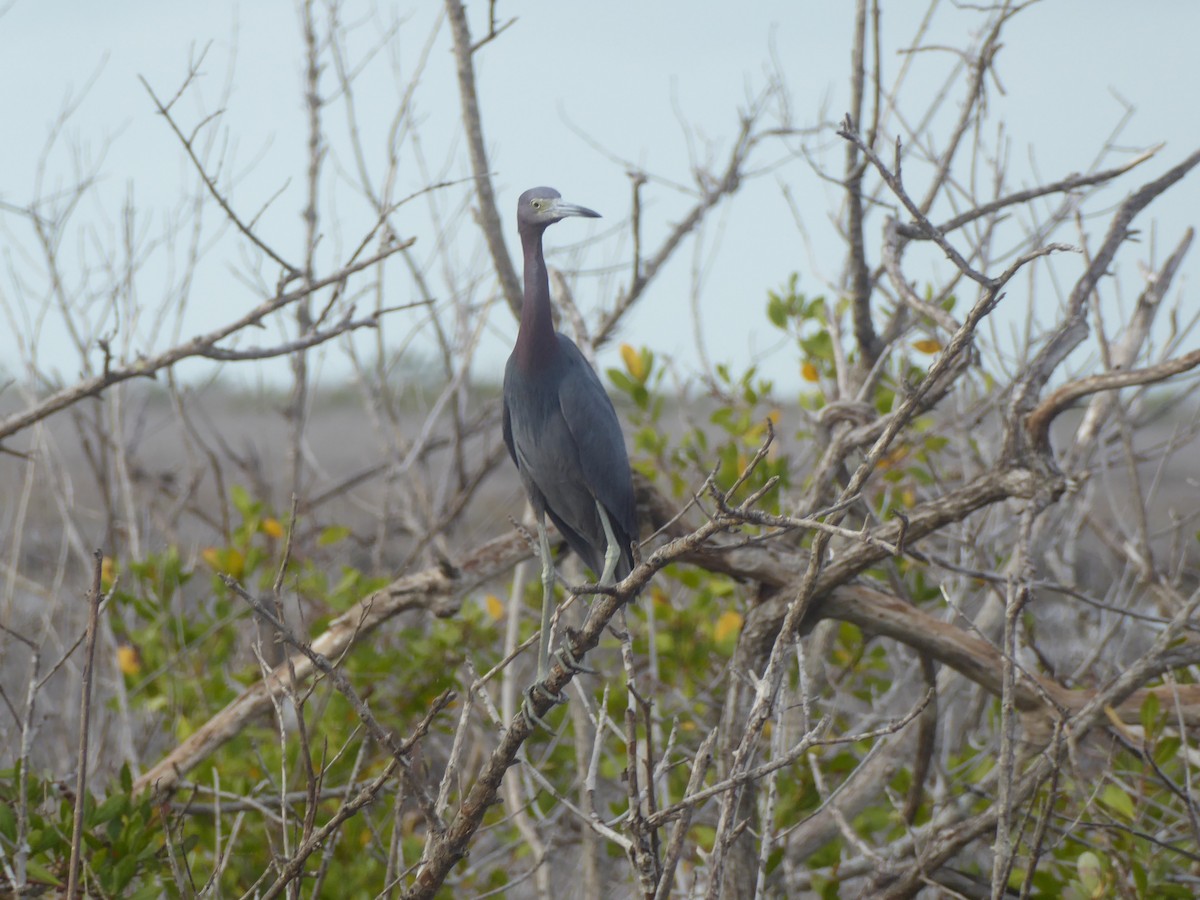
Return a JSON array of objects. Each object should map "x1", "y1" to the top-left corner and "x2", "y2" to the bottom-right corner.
[{"x1": 0, "y1": 0, "x2": 1200, "y2": 391}]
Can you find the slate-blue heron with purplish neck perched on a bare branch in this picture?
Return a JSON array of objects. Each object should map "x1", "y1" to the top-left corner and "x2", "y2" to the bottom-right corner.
[{"x1": 504, "y1": 187, "x2": 637, "y2": 682}]
